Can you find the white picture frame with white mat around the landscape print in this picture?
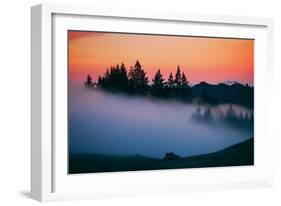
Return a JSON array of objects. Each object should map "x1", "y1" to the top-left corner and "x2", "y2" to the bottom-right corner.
[{"x1": 31, "y1": 4, "x2": 273, "y2": 201}]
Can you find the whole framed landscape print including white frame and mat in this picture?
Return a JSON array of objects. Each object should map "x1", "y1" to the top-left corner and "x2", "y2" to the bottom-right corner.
[{"x1": 31, "y1": 4, "x2": 273, "y2": 201}]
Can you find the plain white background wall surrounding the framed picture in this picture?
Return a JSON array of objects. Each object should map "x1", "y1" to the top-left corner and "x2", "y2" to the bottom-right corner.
[{"x1": 0, "y1": 0, "x2": 281, "y2": 206}]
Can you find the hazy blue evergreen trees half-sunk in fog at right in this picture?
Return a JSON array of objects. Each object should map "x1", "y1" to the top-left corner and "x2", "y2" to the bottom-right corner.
[{"x1": 192, "y1": 105, "x2": 254, "y2": 129}]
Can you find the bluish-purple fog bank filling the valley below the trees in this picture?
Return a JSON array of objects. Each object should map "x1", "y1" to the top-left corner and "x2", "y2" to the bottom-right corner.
[{"x1": 68, "y1": 82, "x2": 253, "y2": 158}]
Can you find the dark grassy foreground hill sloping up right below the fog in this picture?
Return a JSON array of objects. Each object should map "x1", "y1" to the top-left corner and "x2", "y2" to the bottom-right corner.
[{"x1": 69, "y1": 138, "x2": 254, "y2": 174}]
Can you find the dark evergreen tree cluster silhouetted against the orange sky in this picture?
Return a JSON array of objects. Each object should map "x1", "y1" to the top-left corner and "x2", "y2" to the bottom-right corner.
[{"x1": 85, "y1": 60, "x2": 191, "y2": 100}]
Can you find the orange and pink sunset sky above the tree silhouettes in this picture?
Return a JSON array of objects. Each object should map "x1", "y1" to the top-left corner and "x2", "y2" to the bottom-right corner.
[{"x1": 68, "y1": 31, "x2": 254, "y2": 85}]
